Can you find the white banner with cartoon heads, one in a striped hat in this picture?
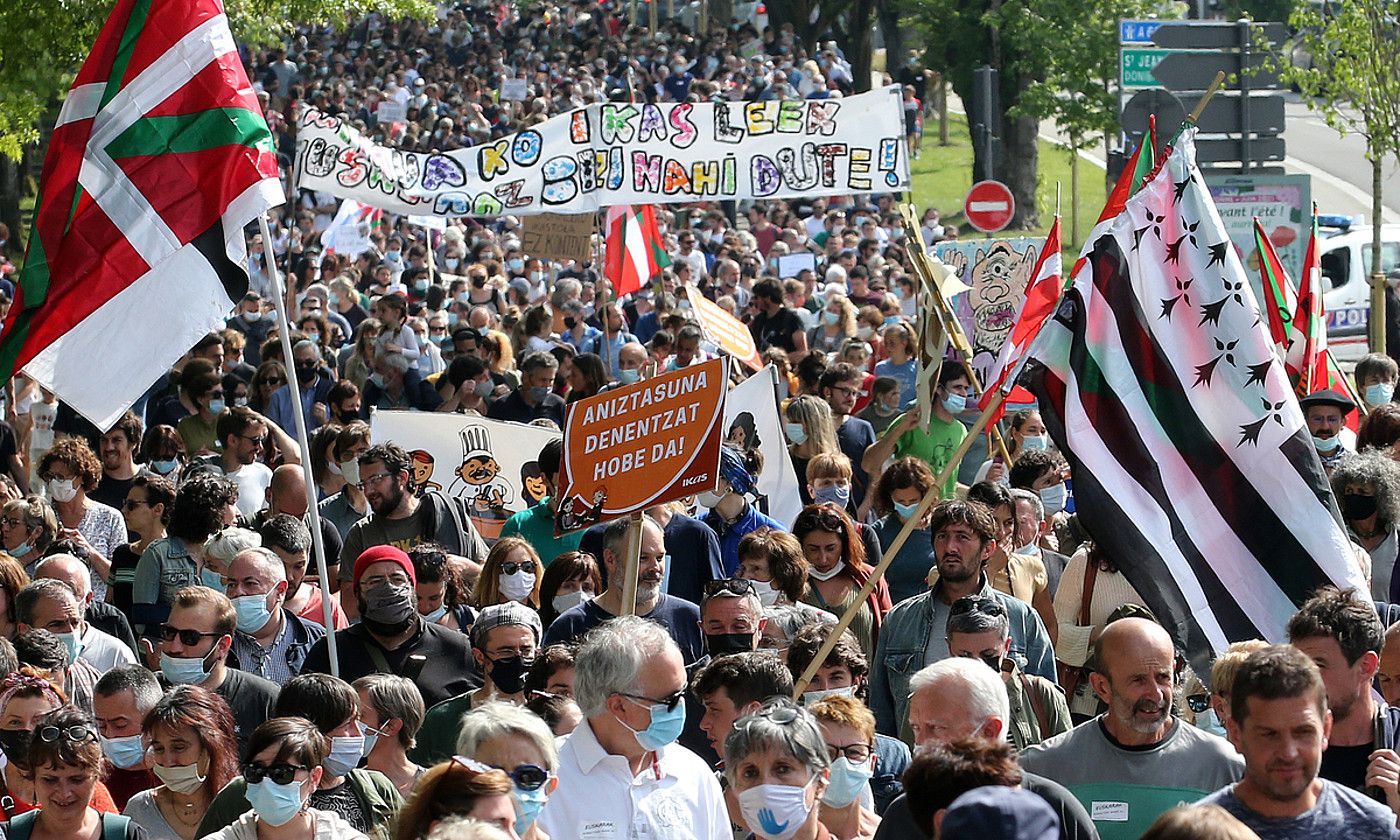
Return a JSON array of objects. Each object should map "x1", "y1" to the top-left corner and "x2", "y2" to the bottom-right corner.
[{"x1": 370, "y1": 412, "x2": 561, "y2": 545}]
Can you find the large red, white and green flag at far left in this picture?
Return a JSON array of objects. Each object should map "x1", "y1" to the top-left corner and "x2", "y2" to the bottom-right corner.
[{"x1": 0, "y1": 0, "x2": 283, "y2": 428}]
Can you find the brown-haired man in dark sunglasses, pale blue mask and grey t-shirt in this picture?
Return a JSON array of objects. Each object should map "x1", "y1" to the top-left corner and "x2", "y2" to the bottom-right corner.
[{"x1": 160, "y1": 587, "x2": 279, "y2": 755}]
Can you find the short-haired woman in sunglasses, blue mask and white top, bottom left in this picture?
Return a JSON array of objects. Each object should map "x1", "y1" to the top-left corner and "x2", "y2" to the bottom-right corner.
[{"x1": 200, "y1": 717, "x2": 365, "y2": 840}]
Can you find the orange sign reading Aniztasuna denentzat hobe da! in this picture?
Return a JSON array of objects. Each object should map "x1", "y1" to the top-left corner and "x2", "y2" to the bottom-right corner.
[{"x1": 554, "y1": 358, "x2": 728, "y2": 533}]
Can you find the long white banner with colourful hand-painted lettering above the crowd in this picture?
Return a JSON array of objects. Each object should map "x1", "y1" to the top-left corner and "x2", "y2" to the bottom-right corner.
[{"x1": 297, "y1": 85, "x2": 910, "y2": 217}]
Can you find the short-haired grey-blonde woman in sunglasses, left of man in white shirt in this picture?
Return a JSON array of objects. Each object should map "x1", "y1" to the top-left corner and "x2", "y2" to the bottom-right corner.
[{"x1": 456, "y1": 701, "x2": 559, "y2": 840}]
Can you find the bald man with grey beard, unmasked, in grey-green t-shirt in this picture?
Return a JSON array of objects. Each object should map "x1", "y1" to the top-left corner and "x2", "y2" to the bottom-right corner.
[{"x1": 1021, "y1": 619, "x2": 1245, "y2": 840}]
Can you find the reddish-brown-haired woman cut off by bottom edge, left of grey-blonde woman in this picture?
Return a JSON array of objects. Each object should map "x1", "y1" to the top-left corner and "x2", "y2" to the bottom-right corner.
[{"x1": 392, "y1": 756, "x2": 521, "y2": 840}]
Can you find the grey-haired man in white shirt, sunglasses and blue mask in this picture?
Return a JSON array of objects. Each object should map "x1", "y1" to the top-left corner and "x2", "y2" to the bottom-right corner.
[{"x1": 538, "y1": 616, "x2": 732, "y2": 840}]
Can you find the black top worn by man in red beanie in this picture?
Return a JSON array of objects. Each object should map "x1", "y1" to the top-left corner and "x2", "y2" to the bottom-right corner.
[{"x1": 301, "y1": 622, "x2": 482, "y2": 708}]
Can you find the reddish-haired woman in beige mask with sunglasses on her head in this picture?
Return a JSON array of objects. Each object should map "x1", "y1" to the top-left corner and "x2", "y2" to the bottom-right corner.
[{"x1": 125, "y1": 686, "x2": 238, "y2": 840}]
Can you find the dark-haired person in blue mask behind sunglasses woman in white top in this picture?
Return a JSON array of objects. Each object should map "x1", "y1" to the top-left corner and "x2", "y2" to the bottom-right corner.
[{"x1": 196, "y1": 673, "x2": 403, "y2": 837}]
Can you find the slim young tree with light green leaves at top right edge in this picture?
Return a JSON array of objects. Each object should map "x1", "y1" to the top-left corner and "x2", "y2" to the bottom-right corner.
[{"x1": 1280, "y1": 0, "x2": 1400, "y2": 353}]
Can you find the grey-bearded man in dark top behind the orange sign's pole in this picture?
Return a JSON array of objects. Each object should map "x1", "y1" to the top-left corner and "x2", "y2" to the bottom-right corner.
[{"x1": 542, "y1": 517, "x2": 704, "y2": 665}]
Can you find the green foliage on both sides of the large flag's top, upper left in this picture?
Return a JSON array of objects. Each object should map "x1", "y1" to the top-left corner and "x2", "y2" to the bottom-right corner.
[{"x1": 0, "y1": 0, "x2": 433, "y2": 158}]
